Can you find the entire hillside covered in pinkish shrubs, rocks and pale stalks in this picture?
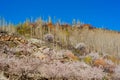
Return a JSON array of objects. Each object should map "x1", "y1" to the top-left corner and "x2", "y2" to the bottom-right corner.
[{"x1": 0, "y1": 19, "x2": 120, "y2": 80}]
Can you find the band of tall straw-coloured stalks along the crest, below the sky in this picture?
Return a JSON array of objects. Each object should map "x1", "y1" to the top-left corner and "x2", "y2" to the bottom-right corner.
[{"x1": 1, "y1": 19, "x2": 120, "y2": 57}]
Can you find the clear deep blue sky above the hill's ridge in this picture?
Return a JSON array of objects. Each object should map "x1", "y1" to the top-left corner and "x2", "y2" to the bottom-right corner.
[{"x1": 0, "y1": 0, "x2": 120, "y2": 31}]
